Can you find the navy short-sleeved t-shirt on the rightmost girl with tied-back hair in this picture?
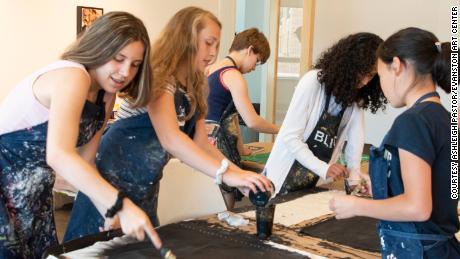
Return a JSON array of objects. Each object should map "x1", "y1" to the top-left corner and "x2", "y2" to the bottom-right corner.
[{"x1": 384, "y1": 102, "x2": 459, "y2": 234}]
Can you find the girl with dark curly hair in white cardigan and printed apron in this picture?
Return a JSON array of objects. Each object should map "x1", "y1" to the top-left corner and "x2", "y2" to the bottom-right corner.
[{"x1": 266, "y1": 33, "x2": 386, "y2": 193}]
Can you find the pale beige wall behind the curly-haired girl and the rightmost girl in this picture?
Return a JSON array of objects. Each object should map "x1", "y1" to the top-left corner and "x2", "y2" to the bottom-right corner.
[{"x1": 313, "y1": 0, "x2": 459, "y2": 145}]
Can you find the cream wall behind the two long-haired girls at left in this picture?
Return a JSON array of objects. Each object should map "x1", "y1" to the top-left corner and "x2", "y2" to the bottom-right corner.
[{"x1": 0, "y1": 0, "x2": 220, "y2": 101}]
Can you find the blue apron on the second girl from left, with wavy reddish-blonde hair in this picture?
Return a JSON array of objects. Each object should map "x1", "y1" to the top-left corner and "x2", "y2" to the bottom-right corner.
[{"x1": 64, "y1": 86, "x2": 197, "y2": 241}]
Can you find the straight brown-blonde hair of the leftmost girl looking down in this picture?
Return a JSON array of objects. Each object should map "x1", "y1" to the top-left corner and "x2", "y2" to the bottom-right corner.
[{"x1": 61, "y1": 12, "x2": 152, "y2": 108}]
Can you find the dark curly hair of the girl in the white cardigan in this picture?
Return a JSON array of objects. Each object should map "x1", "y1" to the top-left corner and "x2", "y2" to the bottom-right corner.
[{"x1": 313, "y1": 32, "x2": 388, "y2": 113}]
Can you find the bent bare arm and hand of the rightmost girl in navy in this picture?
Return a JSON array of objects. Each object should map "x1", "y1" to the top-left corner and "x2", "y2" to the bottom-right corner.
[{"x1": 330, "y1": 149, "x2": 432, "y2": 221}]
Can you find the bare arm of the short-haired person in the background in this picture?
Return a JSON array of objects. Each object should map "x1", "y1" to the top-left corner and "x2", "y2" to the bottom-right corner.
[{"x1": 222, "y1": 70, "x2": 280, "y2": 134}]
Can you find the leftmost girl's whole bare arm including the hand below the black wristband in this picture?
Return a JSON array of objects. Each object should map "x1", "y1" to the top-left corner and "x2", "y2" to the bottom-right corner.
[{"x1": 43, "y1": 68, "x2": 161, "y2": 248}]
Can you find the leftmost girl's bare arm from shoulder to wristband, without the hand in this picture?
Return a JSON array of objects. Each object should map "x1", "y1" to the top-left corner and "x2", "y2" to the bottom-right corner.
[{"x1": 46, "y1": 69, "x2": 117, "y2": 208}]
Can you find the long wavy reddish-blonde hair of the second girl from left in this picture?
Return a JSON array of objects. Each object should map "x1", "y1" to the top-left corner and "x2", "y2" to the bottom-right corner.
[{"x1": 151, "y1": 7, "x2": 222, "y2": 119}]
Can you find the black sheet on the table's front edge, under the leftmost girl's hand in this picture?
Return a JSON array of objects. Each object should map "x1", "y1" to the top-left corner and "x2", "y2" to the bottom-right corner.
[{"x1": 47, "y1": 220, "x2": 308, "y2": 259}]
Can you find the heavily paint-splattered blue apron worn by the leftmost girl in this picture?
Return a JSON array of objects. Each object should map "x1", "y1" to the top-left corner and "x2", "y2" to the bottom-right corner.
[{"x1": 0, "y1": 91, "x2": 105, "y2": 258}]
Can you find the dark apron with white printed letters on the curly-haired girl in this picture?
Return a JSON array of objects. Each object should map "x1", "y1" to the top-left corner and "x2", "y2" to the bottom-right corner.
[{"x1": 280, "y1": 95, "x2": 346, "y2": 194}]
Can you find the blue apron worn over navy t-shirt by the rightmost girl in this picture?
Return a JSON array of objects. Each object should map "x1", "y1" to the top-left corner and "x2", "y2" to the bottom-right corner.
[{"x1": 369, "y1": 92, "x2": 456, "y2": 259}]
